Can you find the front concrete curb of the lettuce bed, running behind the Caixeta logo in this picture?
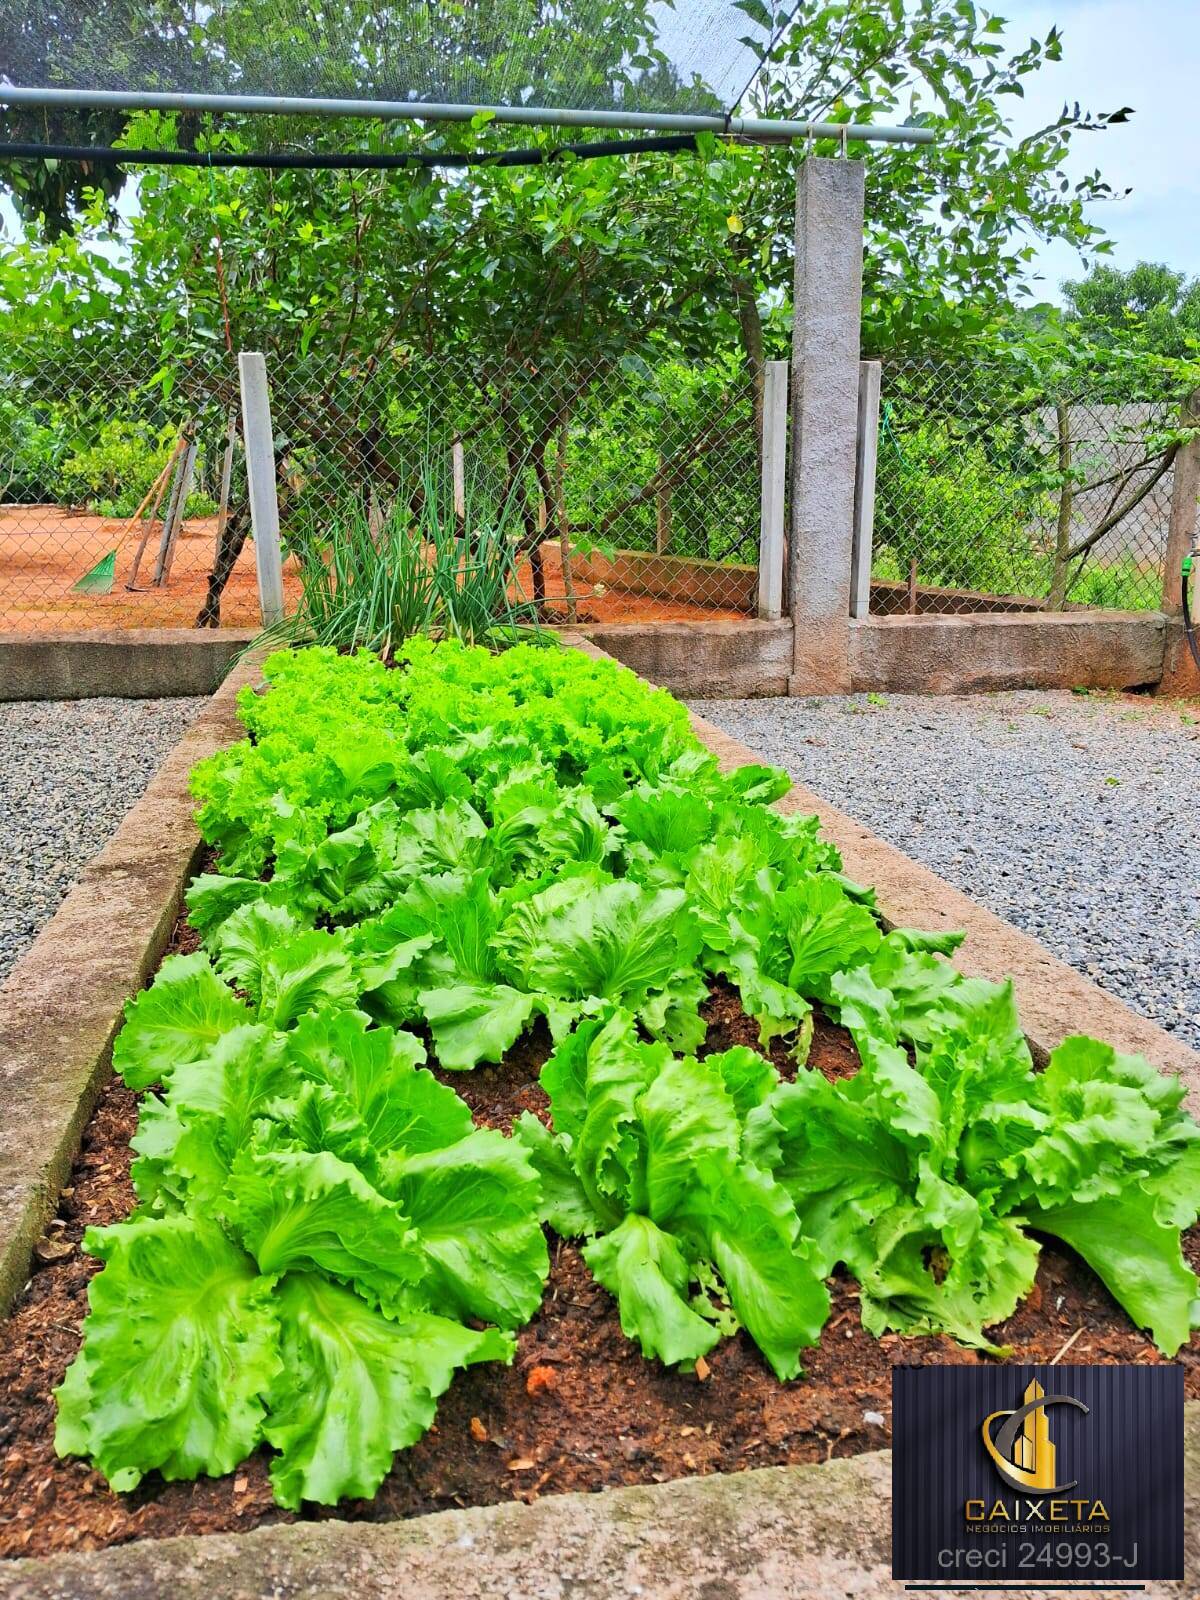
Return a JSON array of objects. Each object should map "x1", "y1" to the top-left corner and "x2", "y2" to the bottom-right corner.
[{"x1": 0, "y1": 1403, "x2": 1200, "y2": 1600}]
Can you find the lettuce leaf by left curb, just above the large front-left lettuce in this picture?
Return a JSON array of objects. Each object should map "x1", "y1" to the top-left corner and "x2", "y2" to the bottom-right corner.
[{"x1": 112, "y1": 950, "x2": 251, "y2": 1090}]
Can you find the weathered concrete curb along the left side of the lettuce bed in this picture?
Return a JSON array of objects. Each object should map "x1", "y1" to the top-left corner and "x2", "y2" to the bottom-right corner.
[{"x1": 0, "y1": 659, "x2": 261, "y2": 1314}]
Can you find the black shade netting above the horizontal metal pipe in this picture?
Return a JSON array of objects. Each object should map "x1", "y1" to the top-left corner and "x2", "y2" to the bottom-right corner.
[{"x1": 0, "y1": 0, "x2": 771, "y2": 112}]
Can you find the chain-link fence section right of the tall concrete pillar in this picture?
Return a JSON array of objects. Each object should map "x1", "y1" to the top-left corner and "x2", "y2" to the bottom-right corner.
[{"x1": 870, "y1": 360, "x2": 1182, "y2": 614}]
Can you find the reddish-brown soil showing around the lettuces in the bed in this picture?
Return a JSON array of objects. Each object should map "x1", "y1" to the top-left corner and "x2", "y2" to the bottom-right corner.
[{"x1": 0, "y1": 926, "x2": 1200, "y2": 1557}]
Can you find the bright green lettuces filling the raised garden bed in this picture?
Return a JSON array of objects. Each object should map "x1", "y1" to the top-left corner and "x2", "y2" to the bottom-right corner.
[{"x1": 58, "y1": 640, "x2": 1200, "y2": 1507}]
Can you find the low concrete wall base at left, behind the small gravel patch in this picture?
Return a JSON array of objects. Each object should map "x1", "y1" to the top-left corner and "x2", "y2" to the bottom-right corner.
[{"x1": 0, "y1": 627, "x2": 254, "y2": 701}]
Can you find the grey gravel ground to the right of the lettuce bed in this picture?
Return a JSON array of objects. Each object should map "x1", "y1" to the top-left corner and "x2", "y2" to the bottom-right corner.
[{"x1": 696, "y1": 691, "x2": 1200, "y2": 1048}]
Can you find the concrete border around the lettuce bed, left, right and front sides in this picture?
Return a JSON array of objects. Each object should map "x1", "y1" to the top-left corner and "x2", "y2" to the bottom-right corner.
[{"x1": 0, "y1": 634, "x2": 1200, "y2": 1600}]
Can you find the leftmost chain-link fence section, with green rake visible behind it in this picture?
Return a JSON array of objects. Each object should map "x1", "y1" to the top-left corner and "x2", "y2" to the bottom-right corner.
[{"x1": 0, "y1": 348, "x2": 258, "y2": 632}]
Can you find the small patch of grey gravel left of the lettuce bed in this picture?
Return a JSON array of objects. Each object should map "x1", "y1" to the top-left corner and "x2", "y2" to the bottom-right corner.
[{"x1": 0, "y1": 699, "x2": 205, "y2": 981}]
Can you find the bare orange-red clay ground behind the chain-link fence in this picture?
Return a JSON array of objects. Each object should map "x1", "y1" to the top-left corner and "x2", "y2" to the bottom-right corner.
[{"x1": 0, "y1": 506, "x2": 741, "y2": 634}]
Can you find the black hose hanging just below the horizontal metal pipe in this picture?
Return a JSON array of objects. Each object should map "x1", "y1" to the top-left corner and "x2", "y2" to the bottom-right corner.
[{"x1": 0, "y1": 133, "x2": 696, "y2": 171}]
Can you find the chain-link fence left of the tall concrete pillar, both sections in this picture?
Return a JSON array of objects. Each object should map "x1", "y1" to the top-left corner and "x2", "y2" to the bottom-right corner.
[{"x1": 0, "y1": 339, "x2": 762, "y2": 630}]
